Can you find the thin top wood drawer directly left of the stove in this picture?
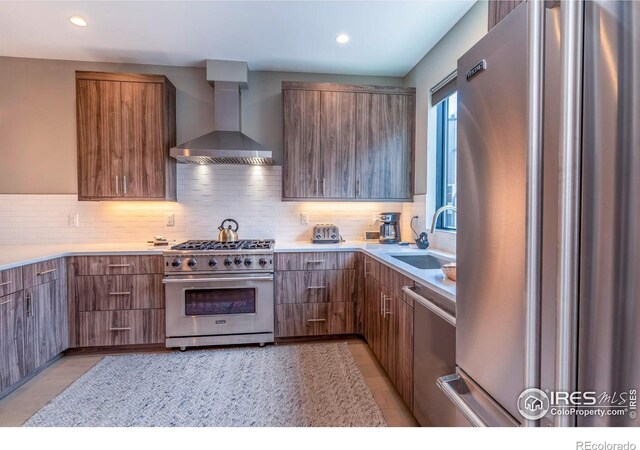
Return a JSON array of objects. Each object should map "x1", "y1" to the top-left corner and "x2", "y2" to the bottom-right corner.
[{"x1": 73, "y1": 255, "x2": 163, "y2": 275}]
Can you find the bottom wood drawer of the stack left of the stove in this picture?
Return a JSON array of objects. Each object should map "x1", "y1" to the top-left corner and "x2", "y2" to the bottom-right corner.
[{"x1": 78, "y1": 309, "x2": 165, "y2": 347}]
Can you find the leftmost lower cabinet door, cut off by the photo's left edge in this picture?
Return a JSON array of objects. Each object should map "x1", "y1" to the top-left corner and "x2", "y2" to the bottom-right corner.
[{"x1": 0, "y1": 291, "x2": 24, "y2": 392}]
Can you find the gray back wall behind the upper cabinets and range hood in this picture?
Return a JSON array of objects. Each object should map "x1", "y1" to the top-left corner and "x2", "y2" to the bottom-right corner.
[{"x1": 0, "y1": 57, "x2": 403, "y2": 194}]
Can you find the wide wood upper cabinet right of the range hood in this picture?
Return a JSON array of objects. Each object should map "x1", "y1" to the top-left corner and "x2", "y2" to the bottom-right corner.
[{"x1": 282, "y1": 81, "x2": 415, "y2": 201}]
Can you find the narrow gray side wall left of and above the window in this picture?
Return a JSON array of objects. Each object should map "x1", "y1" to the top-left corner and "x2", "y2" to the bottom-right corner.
[{"x1": 405, "y1": 0, "x2": 488, "y2": 196}]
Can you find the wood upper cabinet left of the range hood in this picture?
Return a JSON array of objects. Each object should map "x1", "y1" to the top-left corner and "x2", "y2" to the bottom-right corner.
[{"x1": 76, "y1": 72, "x2": 176, "y2": 200}]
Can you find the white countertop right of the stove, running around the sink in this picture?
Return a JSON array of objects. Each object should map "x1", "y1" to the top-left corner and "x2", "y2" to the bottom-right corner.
[{"x1": 275, "y1": 241, "x2": 456, "y2": 301}]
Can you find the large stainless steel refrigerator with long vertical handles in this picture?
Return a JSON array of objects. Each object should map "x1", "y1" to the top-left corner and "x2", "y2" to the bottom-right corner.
[{"x1": 439, "y1": 1, "x2": 640, "y2": 426}]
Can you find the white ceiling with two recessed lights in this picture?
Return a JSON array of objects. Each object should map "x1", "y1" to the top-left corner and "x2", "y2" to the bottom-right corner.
[{"x1": 0, "y1": 0, "x2": 475, "y2": 76}]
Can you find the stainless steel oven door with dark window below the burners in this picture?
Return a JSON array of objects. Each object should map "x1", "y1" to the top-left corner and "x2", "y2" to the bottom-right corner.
[{"x1": 163, "y1": 274, "x2": 274, "y2": 338}]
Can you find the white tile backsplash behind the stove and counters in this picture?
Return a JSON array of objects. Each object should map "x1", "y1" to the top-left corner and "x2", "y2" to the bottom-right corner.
[{"x1": 0, "y1": 164, "x2": 408, "y2": 244}]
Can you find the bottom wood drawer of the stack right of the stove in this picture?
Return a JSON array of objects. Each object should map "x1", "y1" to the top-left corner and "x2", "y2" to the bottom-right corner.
[{"x1": 276, "y1": 302, "x2": 355, "y2": 337}]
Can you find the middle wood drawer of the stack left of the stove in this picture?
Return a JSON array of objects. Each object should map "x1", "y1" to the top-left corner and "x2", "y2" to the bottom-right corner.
[{"x1": 76, "y1": 275, "x2": 164, "y2": 311}]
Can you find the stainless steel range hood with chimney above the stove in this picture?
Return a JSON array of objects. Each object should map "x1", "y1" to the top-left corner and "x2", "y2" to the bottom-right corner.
[{"x1": 171, "y1": 60, "x2": 273, "y2": 165}]
